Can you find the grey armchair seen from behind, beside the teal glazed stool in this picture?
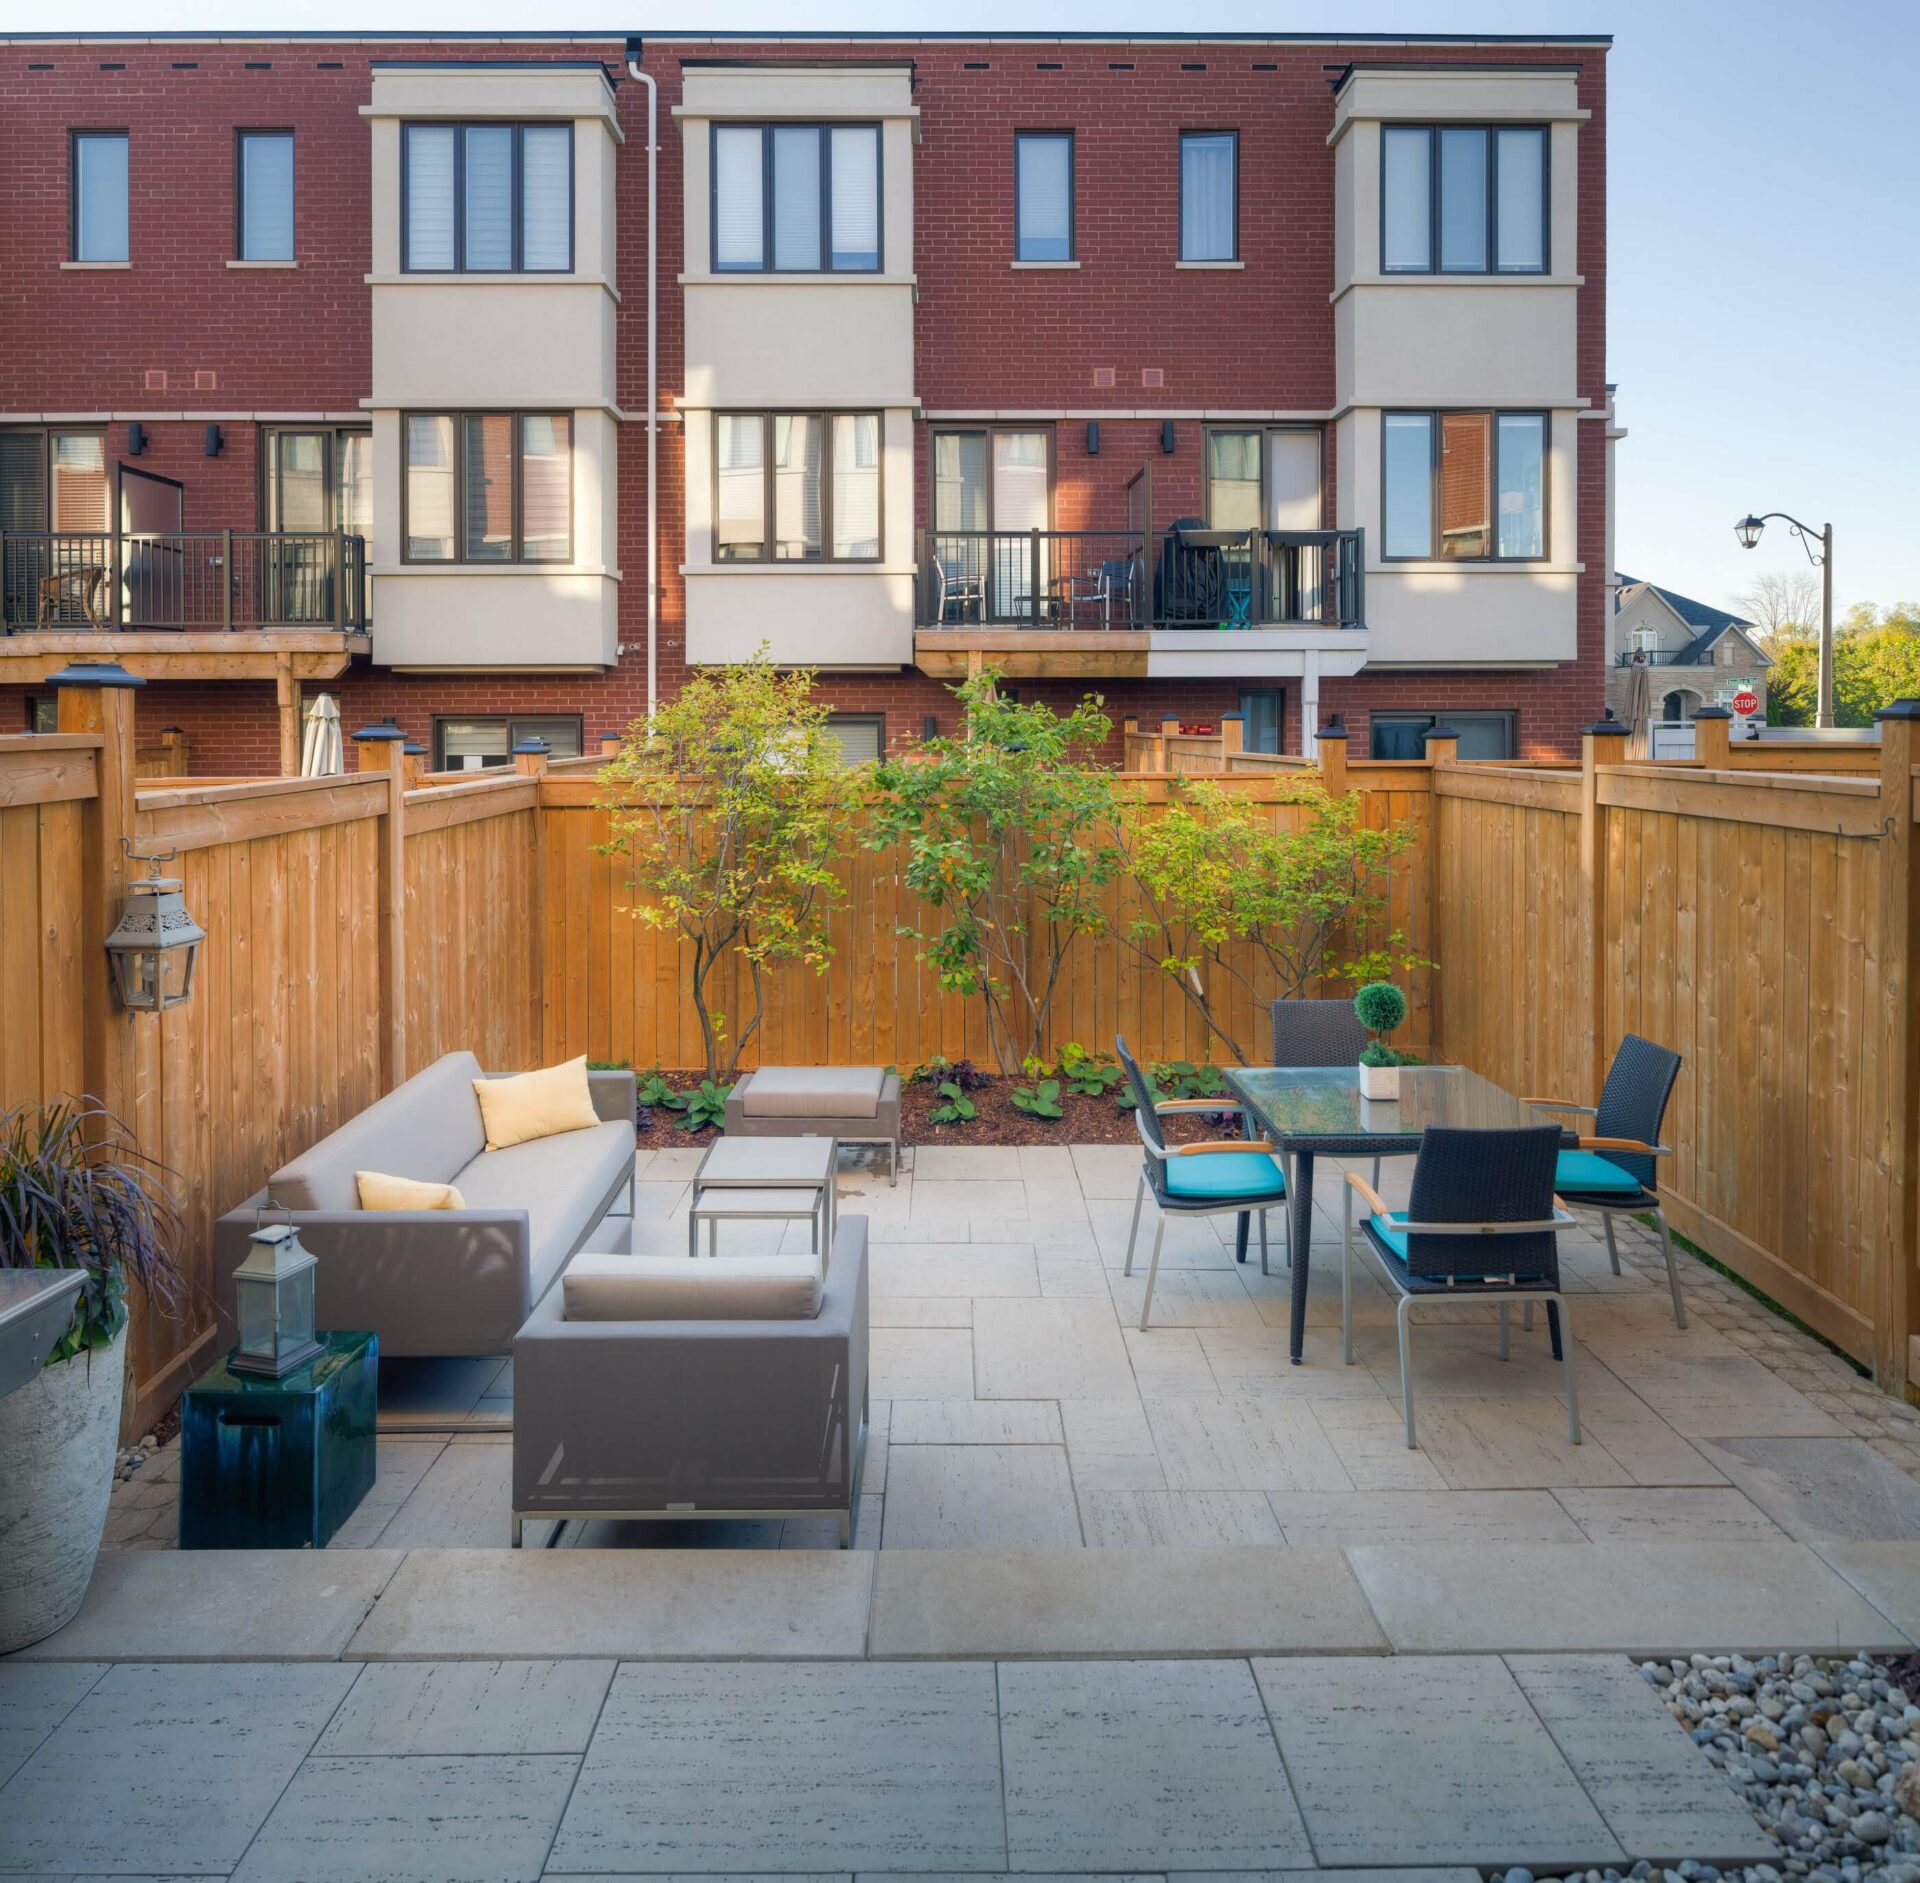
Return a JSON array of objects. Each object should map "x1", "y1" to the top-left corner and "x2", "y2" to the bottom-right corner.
[{"x1": 513, "y1": 1217, "x2": 868, "y2": 1549}]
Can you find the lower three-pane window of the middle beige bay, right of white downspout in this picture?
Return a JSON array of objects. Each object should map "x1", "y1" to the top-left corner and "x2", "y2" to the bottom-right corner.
[{"x1": 712, "y1": 413, "x2": 879, "y2": 562}]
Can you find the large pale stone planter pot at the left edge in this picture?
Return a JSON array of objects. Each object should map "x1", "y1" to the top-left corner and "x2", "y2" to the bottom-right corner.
[{"x1": 0, "y1": 1328, "x2": 127, "y2": 1655}]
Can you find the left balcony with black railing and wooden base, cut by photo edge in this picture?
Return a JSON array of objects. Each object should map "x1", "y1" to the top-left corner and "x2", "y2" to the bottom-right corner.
[{"x1": 0, "y1": 530, "x2": 371, "y2": 681}]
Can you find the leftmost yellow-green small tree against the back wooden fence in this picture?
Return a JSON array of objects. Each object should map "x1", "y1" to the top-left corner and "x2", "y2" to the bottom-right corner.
[{"x1": 601, "y1": 647, "x2": 851, "y2": 1081}]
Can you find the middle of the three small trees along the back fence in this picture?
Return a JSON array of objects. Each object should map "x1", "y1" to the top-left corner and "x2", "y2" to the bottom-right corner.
[{"x1": 868, "y1": 672, "x2": 1121, "y2": 1073}]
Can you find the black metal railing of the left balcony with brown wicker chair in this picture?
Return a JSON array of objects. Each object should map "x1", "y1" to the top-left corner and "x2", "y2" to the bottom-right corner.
[{"x1": 0, "y1": 530, "x2": 367, "y2": 633}]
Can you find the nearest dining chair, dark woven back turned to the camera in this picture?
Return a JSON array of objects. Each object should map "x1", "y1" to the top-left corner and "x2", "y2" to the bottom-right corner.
[{"x1": 1340, "y1": 1125, "x2": 1580, "y2": 1451}]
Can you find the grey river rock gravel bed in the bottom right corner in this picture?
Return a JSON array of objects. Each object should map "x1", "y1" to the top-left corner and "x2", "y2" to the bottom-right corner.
[{"x1": 1486, "y1": 1655, "x2": 1920, "y2": 1883}]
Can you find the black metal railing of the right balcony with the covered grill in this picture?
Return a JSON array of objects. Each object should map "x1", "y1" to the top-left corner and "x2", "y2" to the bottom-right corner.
[{"x1": 918, "y1": 524, "x2": 1365, "y2": 630}]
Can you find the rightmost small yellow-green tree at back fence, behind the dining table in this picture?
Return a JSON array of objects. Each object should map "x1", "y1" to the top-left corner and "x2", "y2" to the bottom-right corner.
[{"x1": 1119, "y1": 775, "x2": 1425, "y2": 1065}]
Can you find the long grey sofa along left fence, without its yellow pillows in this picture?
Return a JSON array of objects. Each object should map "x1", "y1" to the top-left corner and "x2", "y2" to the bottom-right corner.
[{"x1": 213, "y1": 1052, "x2": 634, "y2": 1359}]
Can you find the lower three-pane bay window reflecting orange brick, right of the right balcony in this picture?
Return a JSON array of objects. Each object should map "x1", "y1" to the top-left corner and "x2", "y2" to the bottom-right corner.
[{"x1": 1380, "y1": 413, "x2": 1548, "y2": 562}]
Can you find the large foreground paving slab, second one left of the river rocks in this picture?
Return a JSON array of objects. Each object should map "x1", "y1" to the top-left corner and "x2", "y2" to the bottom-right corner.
[{"x1": 1254, "y1": 1643, "x2": 1622, "y2": 1868}]
